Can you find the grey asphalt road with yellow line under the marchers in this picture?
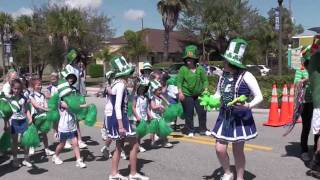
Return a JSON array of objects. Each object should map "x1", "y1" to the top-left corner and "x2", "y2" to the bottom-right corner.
[{"x1": 0, "y1": 98, "x2": 314, "y2": 180}]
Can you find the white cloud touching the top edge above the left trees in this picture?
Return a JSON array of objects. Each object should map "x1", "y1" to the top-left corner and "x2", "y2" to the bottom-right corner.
[{"x1": 51, "y1": 0, "x2": 102, "y2": 9}]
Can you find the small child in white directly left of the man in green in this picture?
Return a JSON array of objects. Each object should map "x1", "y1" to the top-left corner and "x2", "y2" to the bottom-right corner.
[{"x1": 149, "y1": 80, "x2": 173, "y2": 148}]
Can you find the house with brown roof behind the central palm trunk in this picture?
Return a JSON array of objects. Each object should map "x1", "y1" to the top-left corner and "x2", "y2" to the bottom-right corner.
[{"x1": 106, "y1": 28, "x2": 196, "y2": 63}]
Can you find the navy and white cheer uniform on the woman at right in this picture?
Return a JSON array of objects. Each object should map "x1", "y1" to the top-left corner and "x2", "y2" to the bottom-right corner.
[{"x1": 212, "y1": 71, "x2": 263, "y2": 142}]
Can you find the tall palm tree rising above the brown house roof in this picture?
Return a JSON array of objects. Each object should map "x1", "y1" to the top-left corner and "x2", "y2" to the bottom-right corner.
[{"x1": 157, "y1": 0, "x2": 189, "y2": 60}]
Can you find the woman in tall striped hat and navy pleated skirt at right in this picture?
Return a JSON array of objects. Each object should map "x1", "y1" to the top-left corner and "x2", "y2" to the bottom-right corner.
[{"x1": 212, "y1": 38, "x2": 263, "y2": 180}]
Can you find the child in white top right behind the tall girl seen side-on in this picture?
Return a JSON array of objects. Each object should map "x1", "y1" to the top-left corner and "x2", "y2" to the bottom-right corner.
[{"x1": 132, "y1": 78, "x2": 149, "y2": 152}]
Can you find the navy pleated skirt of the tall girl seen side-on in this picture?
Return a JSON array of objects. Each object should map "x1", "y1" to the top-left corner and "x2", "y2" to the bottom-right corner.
[{"x1": 107, "y1": 113, "x2": 136, "y2": 139}]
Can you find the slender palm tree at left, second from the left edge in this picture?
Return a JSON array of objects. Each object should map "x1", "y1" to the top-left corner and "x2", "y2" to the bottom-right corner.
[{"x1": 15, "y1": 15, "x2": 34, "y2": 75}]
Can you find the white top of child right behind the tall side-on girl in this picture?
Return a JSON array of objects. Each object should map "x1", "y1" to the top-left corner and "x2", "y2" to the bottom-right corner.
[{"x1": 132, "y1": 96, "x2": 149, "y2": 121}]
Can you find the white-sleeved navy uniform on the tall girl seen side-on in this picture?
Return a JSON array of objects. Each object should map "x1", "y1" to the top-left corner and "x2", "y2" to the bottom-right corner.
[{"x1": 107, "y1": 79, "x2": 136, "y2": 139}]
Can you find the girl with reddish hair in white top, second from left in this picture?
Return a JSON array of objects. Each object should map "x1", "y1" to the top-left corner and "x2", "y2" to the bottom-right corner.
[{"x1": 29, "y1": 78, "x2": 54, "y2": 156}]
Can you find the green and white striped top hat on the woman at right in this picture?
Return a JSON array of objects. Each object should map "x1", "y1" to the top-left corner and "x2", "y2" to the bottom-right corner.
[{"x1": 222, "y1": 38, "x2": 248, "y2": 69}]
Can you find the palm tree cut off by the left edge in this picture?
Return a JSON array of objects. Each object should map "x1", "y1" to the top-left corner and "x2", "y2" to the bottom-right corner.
[{"x1": 0, "y1": 12, "x2": 13, "y2": 77}]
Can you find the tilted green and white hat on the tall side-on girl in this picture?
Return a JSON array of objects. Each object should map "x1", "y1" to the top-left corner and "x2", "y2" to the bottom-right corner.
[{"x1": 110, "y1": 56, "x2": 134, "y2": 78}]
